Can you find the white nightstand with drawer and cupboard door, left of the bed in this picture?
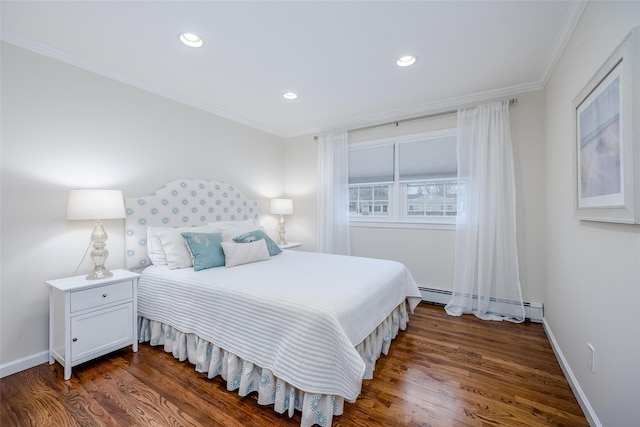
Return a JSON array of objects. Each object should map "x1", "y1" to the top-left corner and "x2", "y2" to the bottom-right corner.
[{"x1": 46, "y1": 270, "x2": 140, "y2": 380}]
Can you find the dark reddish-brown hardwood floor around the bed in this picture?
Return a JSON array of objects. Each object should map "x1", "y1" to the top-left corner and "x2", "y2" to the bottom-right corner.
[{"x1": 0, "y1": 304, "x2": 588, "y2": 427}]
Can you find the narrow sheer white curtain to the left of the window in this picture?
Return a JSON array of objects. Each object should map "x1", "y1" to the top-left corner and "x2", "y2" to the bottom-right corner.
[{"x1": 317, "y1": 132, "x2": 350, "y2": 255}]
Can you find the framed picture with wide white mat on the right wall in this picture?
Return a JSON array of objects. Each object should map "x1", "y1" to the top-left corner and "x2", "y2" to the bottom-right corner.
[{"x1": 573, "y1": 27, "x2": 640, "y2": 224}]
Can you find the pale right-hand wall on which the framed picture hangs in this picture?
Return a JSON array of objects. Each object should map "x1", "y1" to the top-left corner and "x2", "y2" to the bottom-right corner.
[{"x1": 544, "y1": 1, "x2": 640, "y2": 426}]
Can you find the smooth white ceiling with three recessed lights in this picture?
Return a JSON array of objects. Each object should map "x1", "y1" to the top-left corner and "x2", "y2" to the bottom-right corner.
[{"x1": 1, "y1": 0, "x2": 585, "y2": 137}]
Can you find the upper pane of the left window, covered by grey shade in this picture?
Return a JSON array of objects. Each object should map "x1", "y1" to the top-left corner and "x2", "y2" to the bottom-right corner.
[{"x1": 349, "y1": 145, "x2": 393, "y2": 184}]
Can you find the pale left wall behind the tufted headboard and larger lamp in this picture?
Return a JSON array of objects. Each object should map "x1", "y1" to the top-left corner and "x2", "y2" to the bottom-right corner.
[{"x1": 0, "y1": 43, "x2": 284, "y2": 374}]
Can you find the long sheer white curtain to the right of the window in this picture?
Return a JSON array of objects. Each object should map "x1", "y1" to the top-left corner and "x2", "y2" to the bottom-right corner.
[{"x1": 445, "y1": 101, "x2": 525, "y2": 323}]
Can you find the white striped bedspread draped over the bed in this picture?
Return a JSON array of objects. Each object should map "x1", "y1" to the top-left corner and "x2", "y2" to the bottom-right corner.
[{"x1": 138, "y1": 251, "x2": 422, "y2": 401}]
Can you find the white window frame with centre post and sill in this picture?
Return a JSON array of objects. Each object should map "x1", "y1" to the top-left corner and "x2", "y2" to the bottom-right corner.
[{"x1": 349, "y1": 128, "x2": 456, "y2": 230}]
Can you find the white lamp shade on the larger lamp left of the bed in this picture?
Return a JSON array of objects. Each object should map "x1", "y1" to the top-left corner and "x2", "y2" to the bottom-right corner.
[{"x1": 67, "y1": 190, "x2": 125, "y2": 220}]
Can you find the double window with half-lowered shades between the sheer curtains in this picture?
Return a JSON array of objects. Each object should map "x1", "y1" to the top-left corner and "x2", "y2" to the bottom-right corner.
[{"x1": 349, "y1": 129, "x2": 458, "y2": 224}]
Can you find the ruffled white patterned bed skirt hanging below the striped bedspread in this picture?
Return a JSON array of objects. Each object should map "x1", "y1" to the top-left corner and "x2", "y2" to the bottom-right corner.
[{"x1": 138, "y1": 302, "x2": 409, "y2": 427}]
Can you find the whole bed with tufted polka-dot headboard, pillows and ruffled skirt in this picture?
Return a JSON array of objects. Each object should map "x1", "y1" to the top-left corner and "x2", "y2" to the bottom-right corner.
[{"x1": 125, "y1": 179, "x2": 422, "y2": 427}]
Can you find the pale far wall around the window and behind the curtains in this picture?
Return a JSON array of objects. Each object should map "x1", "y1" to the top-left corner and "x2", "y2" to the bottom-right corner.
[{"x1": 285, "y1": 91, "x2": 545, "y2": 302}]
